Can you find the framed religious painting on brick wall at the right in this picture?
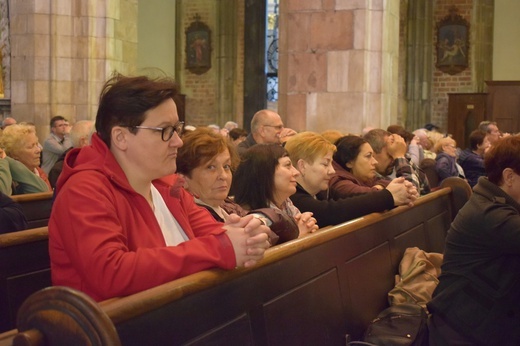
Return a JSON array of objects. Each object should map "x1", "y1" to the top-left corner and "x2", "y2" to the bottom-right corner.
[{"x1": 435, "y1": 7, "x2": 469, "y2": 75}]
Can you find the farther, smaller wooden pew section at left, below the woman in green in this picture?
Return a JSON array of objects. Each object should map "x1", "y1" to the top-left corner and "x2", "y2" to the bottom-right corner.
[{"x1": 11, "y1": 191, "x2": 53, "y2": 228}]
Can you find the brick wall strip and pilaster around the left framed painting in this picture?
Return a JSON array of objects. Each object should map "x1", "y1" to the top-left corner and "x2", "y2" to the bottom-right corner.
[{"x1": 177, "y1": 0, "x2": 244, "y2": 126}]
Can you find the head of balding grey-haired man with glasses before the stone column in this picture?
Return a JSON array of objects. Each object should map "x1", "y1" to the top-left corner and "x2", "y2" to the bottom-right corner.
[{"x1": 237, "y1": 109, "x2": 296, "y2": 156}]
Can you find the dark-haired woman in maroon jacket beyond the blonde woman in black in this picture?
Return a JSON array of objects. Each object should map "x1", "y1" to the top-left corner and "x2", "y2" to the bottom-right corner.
[{"x1": 329, "y1": 135, "x2": 402, "y2": 199}]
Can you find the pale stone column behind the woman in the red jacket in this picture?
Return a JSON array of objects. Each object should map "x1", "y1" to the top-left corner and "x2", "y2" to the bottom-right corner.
[{"x1": 9, "y1": 0, "x2": 137, "y2": 141}]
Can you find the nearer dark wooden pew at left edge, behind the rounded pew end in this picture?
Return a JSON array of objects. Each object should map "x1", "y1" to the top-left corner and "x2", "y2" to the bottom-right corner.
[{"x1": 0, "y1": 227, "x2": 51, "y2": 333}]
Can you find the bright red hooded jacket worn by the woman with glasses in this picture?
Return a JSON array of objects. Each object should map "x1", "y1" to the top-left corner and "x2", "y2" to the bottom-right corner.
[{"x1": 49, "y1": 135, "x2": 236, "y2": 301}]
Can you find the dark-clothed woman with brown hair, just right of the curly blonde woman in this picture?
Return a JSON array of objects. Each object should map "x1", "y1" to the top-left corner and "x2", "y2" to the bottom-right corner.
[{"x1": 458, "y1": 130, "x2": 490, "y2": 187}]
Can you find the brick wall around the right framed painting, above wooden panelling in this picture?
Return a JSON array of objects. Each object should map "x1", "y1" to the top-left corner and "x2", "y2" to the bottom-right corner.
[{"x1": 431, "y1": 0, "x2": 475, "y2": 131}]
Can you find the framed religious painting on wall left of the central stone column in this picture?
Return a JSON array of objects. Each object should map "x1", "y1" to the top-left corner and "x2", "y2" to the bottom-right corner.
[{"x1": 185, "y1": 15, "x2": 211, "y2": 74}]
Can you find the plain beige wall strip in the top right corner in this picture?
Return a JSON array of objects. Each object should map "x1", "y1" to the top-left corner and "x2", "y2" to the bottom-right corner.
[{"x1": 493, "y1": 0, "x2": 520, "y2": 80}]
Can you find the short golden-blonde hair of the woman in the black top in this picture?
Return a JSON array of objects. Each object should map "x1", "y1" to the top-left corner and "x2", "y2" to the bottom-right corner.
[{"x1": 285, "y1": 131, "x2": 336, "y2": 167}]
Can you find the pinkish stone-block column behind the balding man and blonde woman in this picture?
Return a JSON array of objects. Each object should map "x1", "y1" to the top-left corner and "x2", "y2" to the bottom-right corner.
[{"x1": 278, "y1": 0, "x2": 399, "y2": 133}]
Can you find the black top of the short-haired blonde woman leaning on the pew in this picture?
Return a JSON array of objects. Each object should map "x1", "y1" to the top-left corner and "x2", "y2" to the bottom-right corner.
[{"x1": 290, "y1": 184, "x2": 394, "y2": 227}]
